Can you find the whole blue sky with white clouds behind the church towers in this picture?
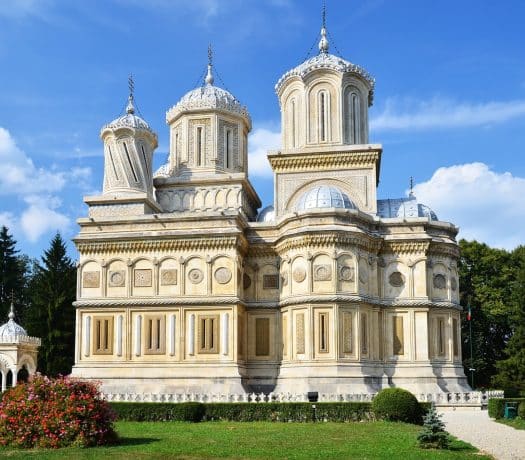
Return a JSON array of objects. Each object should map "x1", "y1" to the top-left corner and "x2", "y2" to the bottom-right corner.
[{"x1": 0, "y1": 0, "x2": 525, "y2": 257}]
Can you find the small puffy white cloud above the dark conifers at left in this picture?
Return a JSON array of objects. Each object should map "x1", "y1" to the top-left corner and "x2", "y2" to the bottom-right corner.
[{"x1": 20, "y1": 195, "x2": 71, "y2": 243}]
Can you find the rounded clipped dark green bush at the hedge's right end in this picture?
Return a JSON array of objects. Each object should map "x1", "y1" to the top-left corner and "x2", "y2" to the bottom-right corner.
[{"x1": 372, "y1": 388, "x2": 423, "y2": 424}]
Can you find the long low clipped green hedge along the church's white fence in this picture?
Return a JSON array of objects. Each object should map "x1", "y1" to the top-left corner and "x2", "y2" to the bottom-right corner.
[{"x1": 110, "y1": 402, "x2": 430, "y2": 422}]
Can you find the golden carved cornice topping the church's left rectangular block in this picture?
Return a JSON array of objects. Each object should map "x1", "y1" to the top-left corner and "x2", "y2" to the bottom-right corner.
[{"x1": 75, "y1": 236, "x2": 243, "y2": 255}]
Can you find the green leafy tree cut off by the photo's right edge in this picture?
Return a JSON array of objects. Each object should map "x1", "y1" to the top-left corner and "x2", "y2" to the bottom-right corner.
[{"x1": 493, "y1": 246, "x2": 525, "y2": 392}]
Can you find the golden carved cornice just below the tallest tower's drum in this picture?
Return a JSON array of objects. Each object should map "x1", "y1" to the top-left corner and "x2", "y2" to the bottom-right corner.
[{"x1": 268, "y1": 149, "x2": 381, "y2": 173}]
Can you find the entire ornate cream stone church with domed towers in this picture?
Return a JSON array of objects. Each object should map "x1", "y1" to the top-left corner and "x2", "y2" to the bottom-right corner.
[{"x1": 73, "y1": 21, "x2": 469, "y2": 394}]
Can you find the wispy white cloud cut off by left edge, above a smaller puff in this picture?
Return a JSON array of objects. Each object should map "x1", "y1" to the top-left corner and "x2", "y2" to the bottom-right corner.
[{"x1": 0, "y1": 127, "x2": 66, "y2": 195}]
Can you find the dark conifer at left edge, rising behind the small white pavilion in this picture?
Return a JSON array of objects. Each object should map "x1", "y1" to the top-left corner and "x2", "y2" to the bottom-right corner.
[{"x1": 0, "y1": 226, "x2": 28, "y2": 321}]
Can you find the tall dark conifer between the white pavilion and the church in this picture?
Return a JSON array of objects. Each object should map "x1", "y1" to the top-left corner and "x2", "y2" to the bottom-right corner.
[{"x1": 26, "y1": 233, "x2": 76, "y2": 376}]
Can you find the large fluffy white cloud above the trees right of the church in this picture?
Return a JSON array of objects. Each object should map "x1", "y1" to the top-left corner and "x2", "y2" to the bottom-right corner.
[{"x1": 414, "y1": 163, "x2": 525, "y2": 249}]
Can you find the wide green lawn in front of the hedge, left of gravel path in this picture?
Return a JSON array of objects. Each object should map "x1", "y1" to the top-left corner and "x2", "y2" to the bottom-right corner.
[{"x1": 0, "y1": 422, "x2": 490, "y2": 460}]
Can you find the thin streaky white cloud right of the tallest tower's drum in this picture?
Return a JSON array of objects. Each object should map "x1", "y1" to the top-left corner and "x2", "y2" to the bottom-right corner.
[{"x1": 370, "y1": 97, "x2": 525, "y2": 131}]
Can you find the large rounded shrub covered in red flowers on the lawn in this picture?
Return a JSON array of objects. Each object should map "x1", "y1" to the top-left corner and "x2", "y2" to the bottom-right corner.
[{"x1": 0, "y1": 374, "x2": 116, "y2": 448}]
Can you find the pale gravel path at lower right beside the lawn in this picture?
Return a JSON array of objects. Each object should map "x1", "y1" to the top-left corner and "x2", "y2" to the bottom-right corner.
[{"x1": 442, "y1": 410, "x2": 525, "y2": 460}]
